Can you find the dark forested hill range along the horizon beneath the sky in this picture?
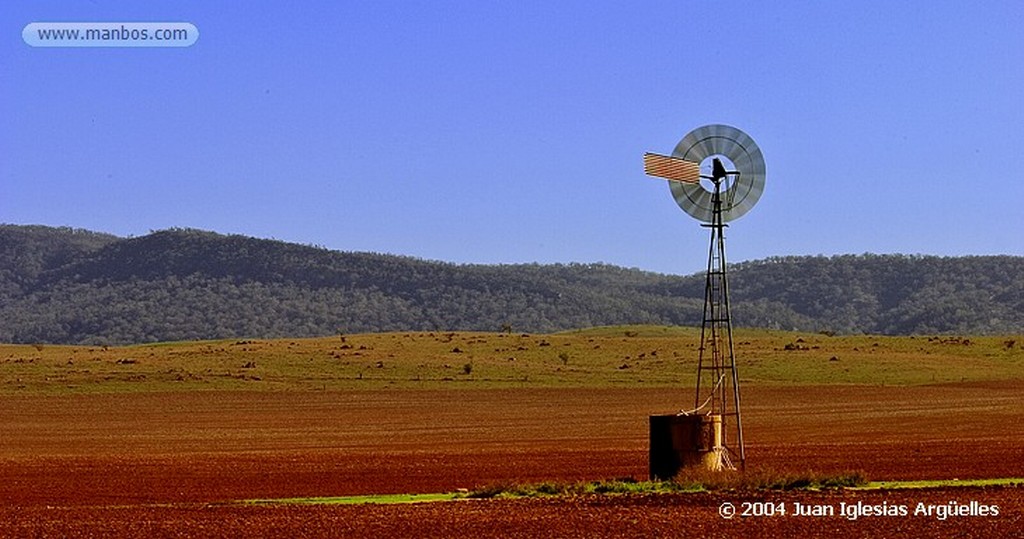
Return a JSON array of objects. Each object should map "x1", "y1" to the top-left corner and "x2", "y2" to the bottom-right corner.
[{"x1": 0, "y1": 225, "x2": 1024, "y2": 344}]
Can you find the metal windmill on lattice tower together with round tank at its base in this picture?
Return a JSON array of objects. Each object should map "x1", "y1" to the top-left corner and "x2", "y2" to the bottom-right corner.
[{"x1": 643, "y1": 124, "x2": 765, "y2": 479}]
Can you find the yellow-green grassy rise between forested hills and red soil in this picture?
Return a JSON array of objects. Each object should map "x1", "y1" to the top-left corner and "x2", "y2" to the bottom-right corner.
[{"x1": 0, "y1": 326, "x2": 1024, "y2": 395}]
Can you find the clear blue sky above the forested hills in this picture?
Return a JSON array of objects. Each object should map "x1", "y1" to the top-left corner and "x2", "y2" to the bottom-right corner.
[{"x1": 0, "y1": 0, "x2": 1024, "y2": 274}]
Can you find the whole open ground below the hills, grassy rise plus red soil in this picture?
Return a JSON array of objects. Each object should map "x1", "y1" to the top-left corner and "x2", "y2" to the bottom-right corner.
[{"x1": 0, "y1": 327, "x2": 1024, "y2": 537}]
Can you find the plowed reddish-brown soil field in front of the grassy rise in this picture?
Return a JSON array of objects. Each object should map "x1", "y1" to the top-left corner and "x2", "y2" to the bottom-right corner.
[{"x1": 0, "y1": 382, "x2": 1024, "y2": 537}]
